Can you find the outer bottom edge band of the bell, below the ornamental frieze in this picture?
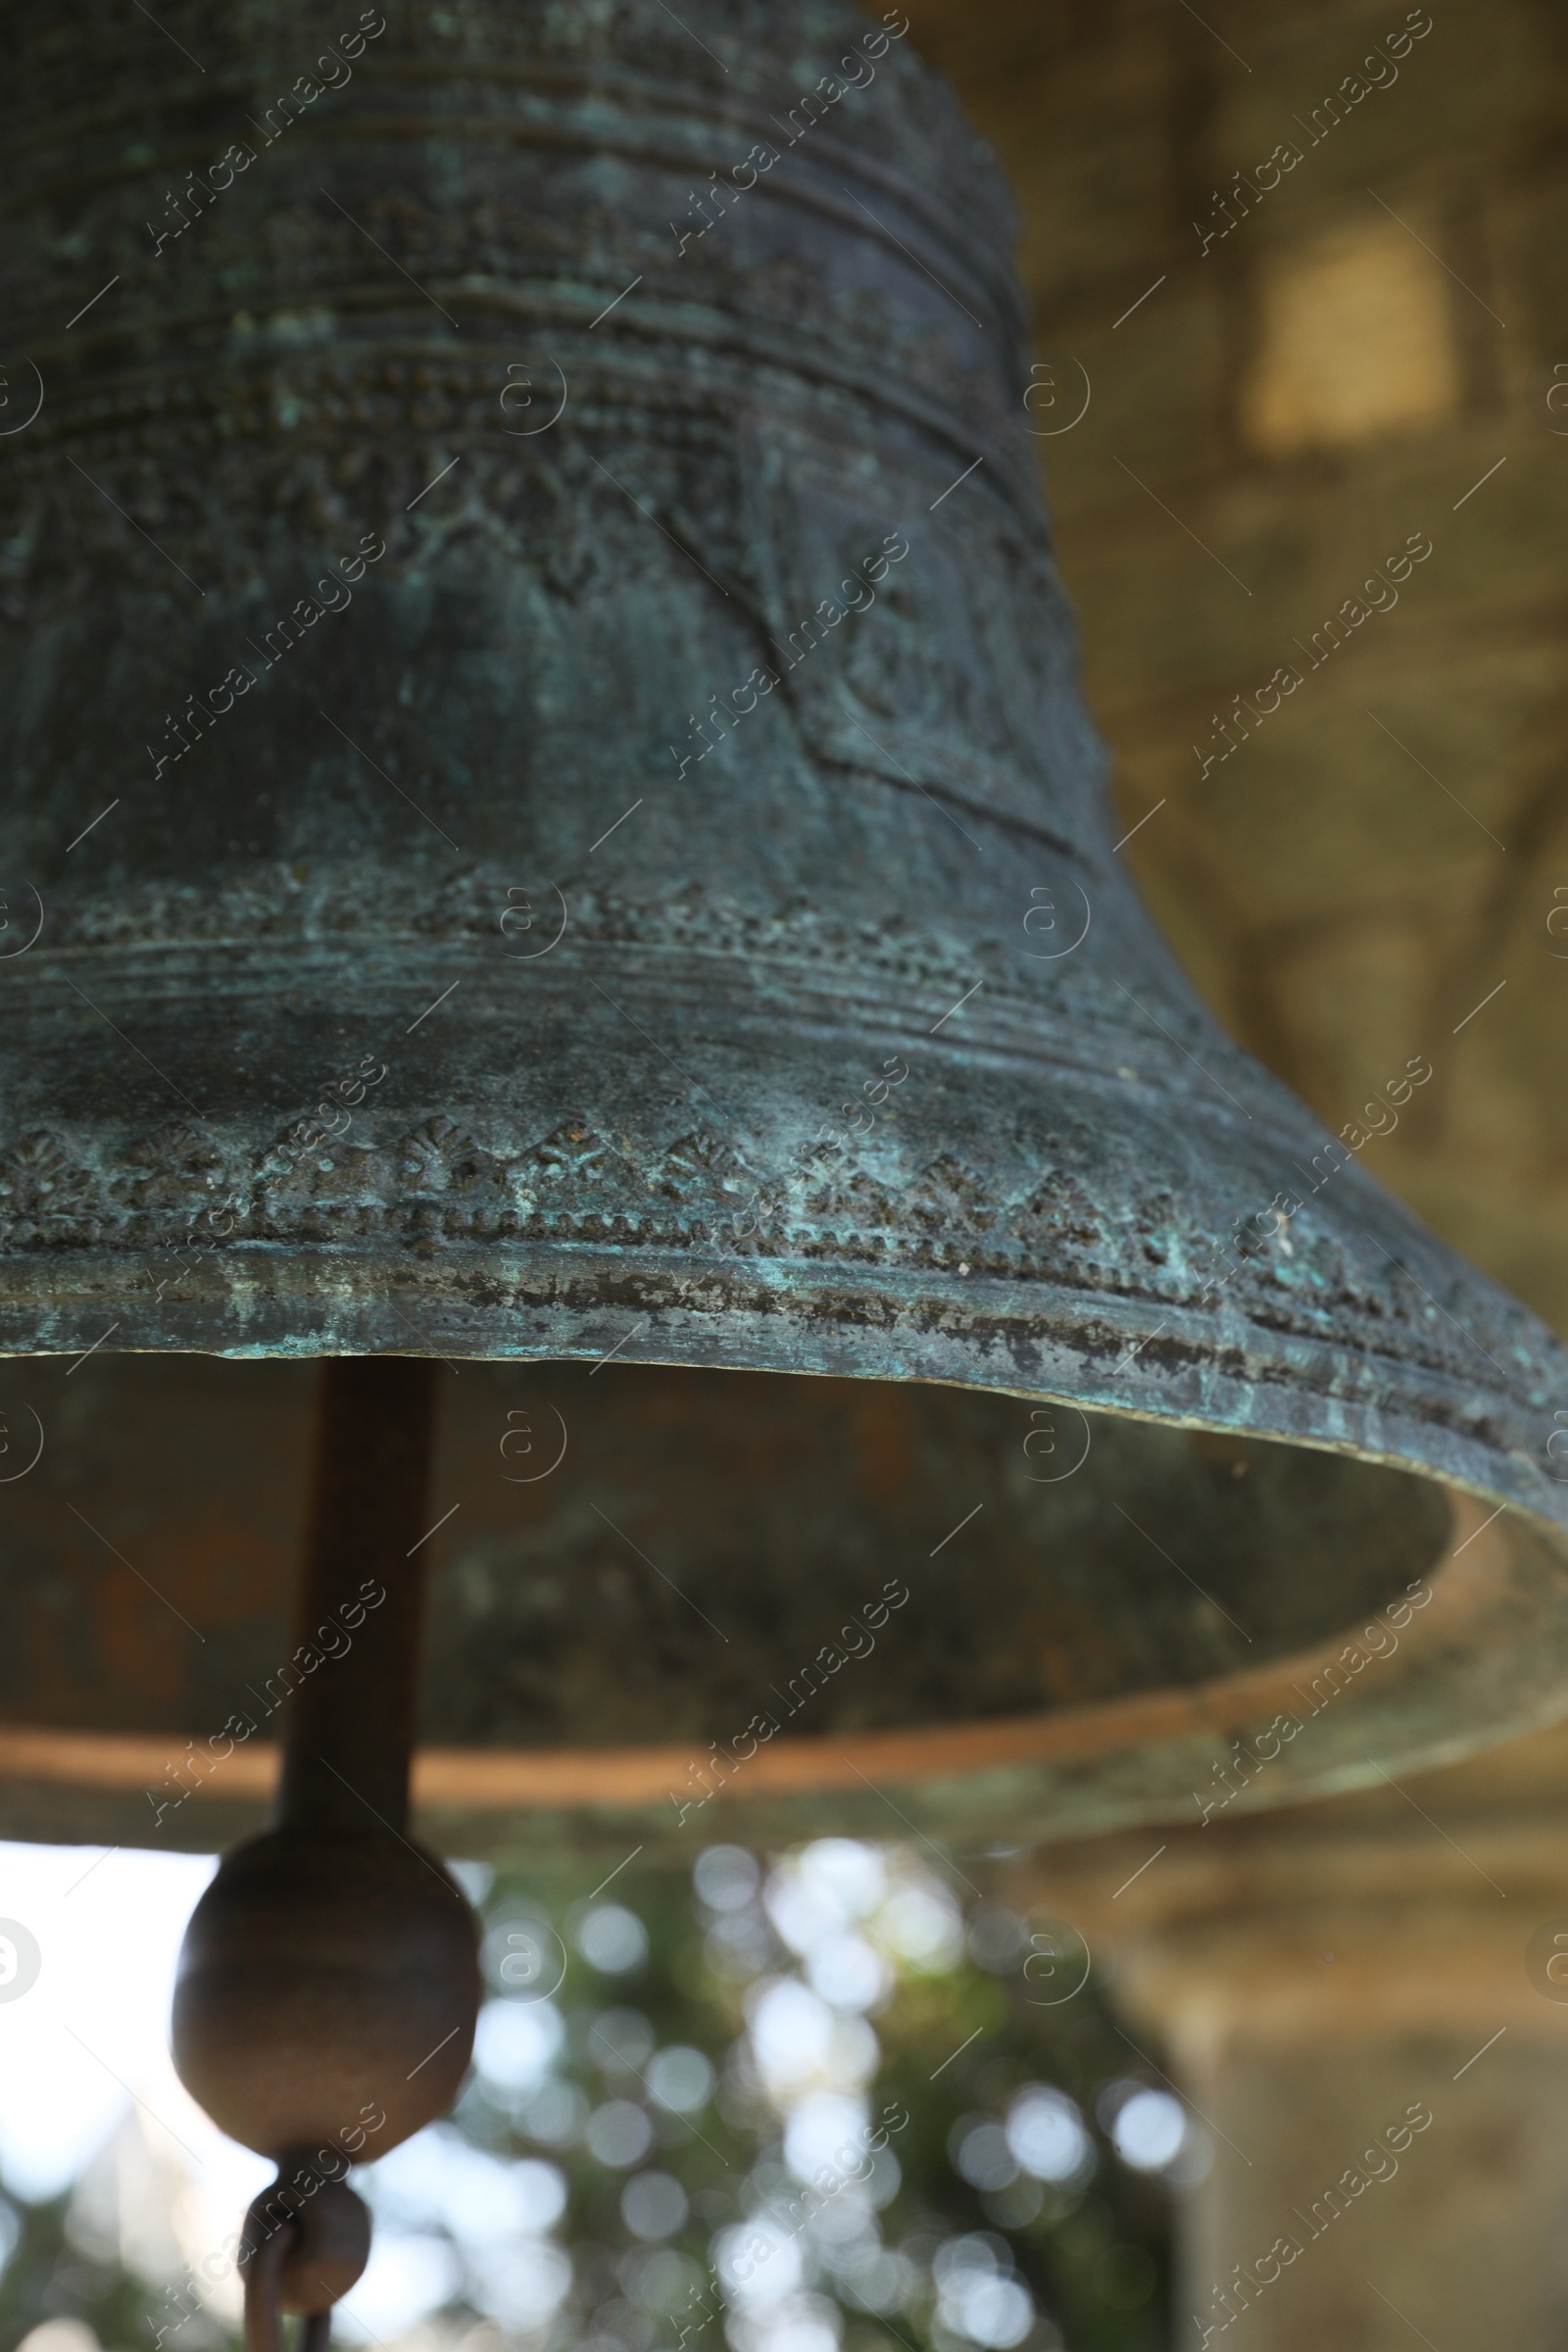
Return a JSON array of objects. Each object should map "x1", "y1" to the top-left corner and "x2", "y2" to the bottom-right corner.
[{"x1": 0, "y1": 1242, "x2": 1568, "y2": 1534}]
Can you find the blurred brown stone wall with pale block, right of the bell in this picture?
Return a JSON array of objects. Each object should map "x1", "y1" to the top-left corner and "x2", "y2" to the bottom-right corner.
[{"x1": 907, "y1": 0, "x2": 1568, "y2": 1329}]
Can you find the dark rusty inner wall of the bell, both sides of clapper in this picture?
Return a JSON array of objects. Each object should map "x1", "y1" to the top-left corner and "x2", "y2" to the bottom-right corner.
[{"x1": 0, "y1": 1357, "x2": 1450, "y2": 1750}]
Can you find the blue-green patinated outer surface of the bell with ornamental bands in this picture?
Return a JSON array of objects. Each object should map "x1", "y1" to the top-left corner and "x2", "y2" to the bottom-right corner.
[{"x1": 0, "y1": 0, "x2": 1568, "y2": 1818}]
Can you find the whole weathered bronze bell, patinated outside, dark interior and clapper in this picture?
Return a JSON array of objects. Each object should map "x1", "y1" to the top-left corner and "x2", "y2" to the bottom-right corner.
[{"x1": 0, "y1": 0, "x2": 1568, "y2": 2277}]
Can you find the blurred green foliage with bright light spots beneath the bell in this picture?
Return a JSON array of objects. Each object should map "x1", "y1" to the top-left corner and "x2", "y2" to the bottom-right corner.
[{"x1": 0, "y1": 1839, "x2": 1175, "y2": 2352}]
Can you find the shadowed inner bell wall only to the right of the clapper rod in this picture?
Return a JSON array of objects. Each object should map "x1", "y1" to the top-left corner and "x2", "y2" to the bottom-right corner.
[{"x1": 414, "y1": 1364, "x2": 1448, "y2": 1747}]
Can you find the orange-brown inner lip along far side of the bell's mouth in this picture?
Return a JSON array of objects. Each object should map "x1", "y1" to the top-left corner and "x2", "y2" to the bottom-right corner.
[{"x1": 0, "y1": 1489, "x2": 1568, "y2": 1860}]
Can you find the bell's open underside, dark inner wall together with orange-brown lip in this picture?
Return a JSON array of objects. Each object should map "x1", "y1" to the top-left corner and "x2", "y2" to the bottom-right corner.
[{"x1": 0, "y1": 1357, "x2": 1568, "y2": 1858}]
